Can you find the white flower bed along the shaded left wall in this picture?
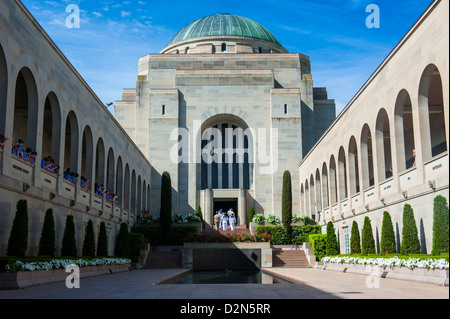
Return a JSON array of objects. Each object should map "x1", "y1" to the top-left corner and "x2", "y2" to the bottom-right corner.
[{"x1": 6, "y1": 258, "x2": 131, "y2": 272}]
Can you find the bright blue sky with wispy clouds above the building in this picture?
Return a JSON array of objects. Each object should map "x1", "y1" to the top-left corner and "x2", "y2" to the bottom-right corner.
[{"x1": 22, "y1": 0, "x2": 431, "y2": 113}]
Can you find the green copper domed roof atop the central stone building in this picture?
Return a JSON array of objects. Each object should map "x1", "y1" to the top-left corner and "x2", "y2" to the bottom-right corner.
[{"x1": 167, "y1": 13, "x2": 281, "y2": 46}]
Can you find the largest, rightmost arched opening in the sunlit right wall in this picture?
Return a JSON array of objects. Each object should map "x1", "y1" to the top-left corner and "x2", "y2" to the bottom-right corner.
[{"x1": 419, "y1": 64, "x2": 447, "y2": 161}]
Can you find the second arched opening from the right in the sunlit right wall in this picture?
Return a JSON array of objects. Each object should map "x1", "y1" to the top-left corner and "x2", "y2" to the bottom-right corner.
[{"x1": 394, "y1": 90, "x2": 416, "y2": 172}]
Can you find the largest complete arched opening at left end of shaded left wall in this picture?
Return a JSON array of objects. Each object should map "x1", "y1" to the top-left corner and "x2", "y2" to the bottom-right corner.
[{"x1": 13, "y1": 68, "x2": 38, "y2": 150}]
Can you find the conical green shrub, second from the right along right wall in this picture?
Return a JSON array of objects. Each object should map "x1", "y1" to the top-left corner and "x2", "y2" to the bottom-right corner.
[{"x1": 400, "y1": 204, "x2": 420, "y2": 255}]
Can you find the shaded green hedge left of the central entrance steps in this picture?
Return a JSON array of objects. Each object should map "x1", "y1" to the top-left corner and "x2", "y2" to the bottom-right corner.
[{"x1": 131, "y1": 224, "x2": 197, "y2": 246}]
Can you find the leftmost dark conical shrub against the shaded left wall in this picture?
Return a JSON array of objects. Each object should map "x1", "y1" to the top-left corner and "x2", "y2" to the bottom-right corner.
[{"x1": 6, "y1": 200, "x2": 28, "y2": 257}]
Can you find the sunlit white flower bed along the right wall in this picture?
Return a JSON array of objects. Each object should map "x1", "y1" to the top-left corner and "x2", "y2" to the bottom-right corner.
[{"x1": 321, "y1": 257, "x2": 449, "y2": 269}]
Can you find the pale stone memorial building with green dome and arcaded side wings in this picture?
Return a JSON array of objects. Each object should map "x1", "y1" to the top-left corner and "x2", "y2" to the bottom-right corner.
[{"x1": 0, "y1": 0, "x2": 449, "y2": 256}]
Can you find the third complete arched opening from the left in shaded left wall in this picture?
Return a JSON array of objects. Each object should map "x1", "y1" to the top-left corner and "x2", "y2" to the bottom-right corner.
[{"x1": 64, "y1": 111, "x2": 79, "y2": 174}]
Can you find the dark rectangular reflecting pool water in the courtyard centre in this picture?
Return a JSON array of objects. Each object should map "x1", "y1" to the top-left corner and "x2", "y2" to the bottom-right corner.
[{"x1": 161, "y1": 271, "x2": 291, "y2": 285}]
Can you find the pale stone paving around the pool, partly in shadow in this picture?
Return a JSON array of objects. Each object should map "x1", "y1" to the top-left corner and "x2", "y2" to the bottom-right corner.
[{"x1": 0, "y1": 268, "x2": 449, "y2": 300}]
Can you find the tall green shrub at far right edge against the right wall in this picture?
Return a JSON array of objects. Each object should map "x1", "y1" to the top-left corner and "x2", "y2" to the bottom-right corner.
[{"x1": 431, "y1": 195, "x2": 449, "y2": 256}]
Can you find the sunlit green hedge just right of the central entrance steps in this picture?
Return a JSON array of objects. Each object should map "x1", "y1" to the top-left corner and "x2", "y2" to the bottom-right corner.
[{"x1": 256, "y1": 225, "x2": 322, "y2": 245}]
